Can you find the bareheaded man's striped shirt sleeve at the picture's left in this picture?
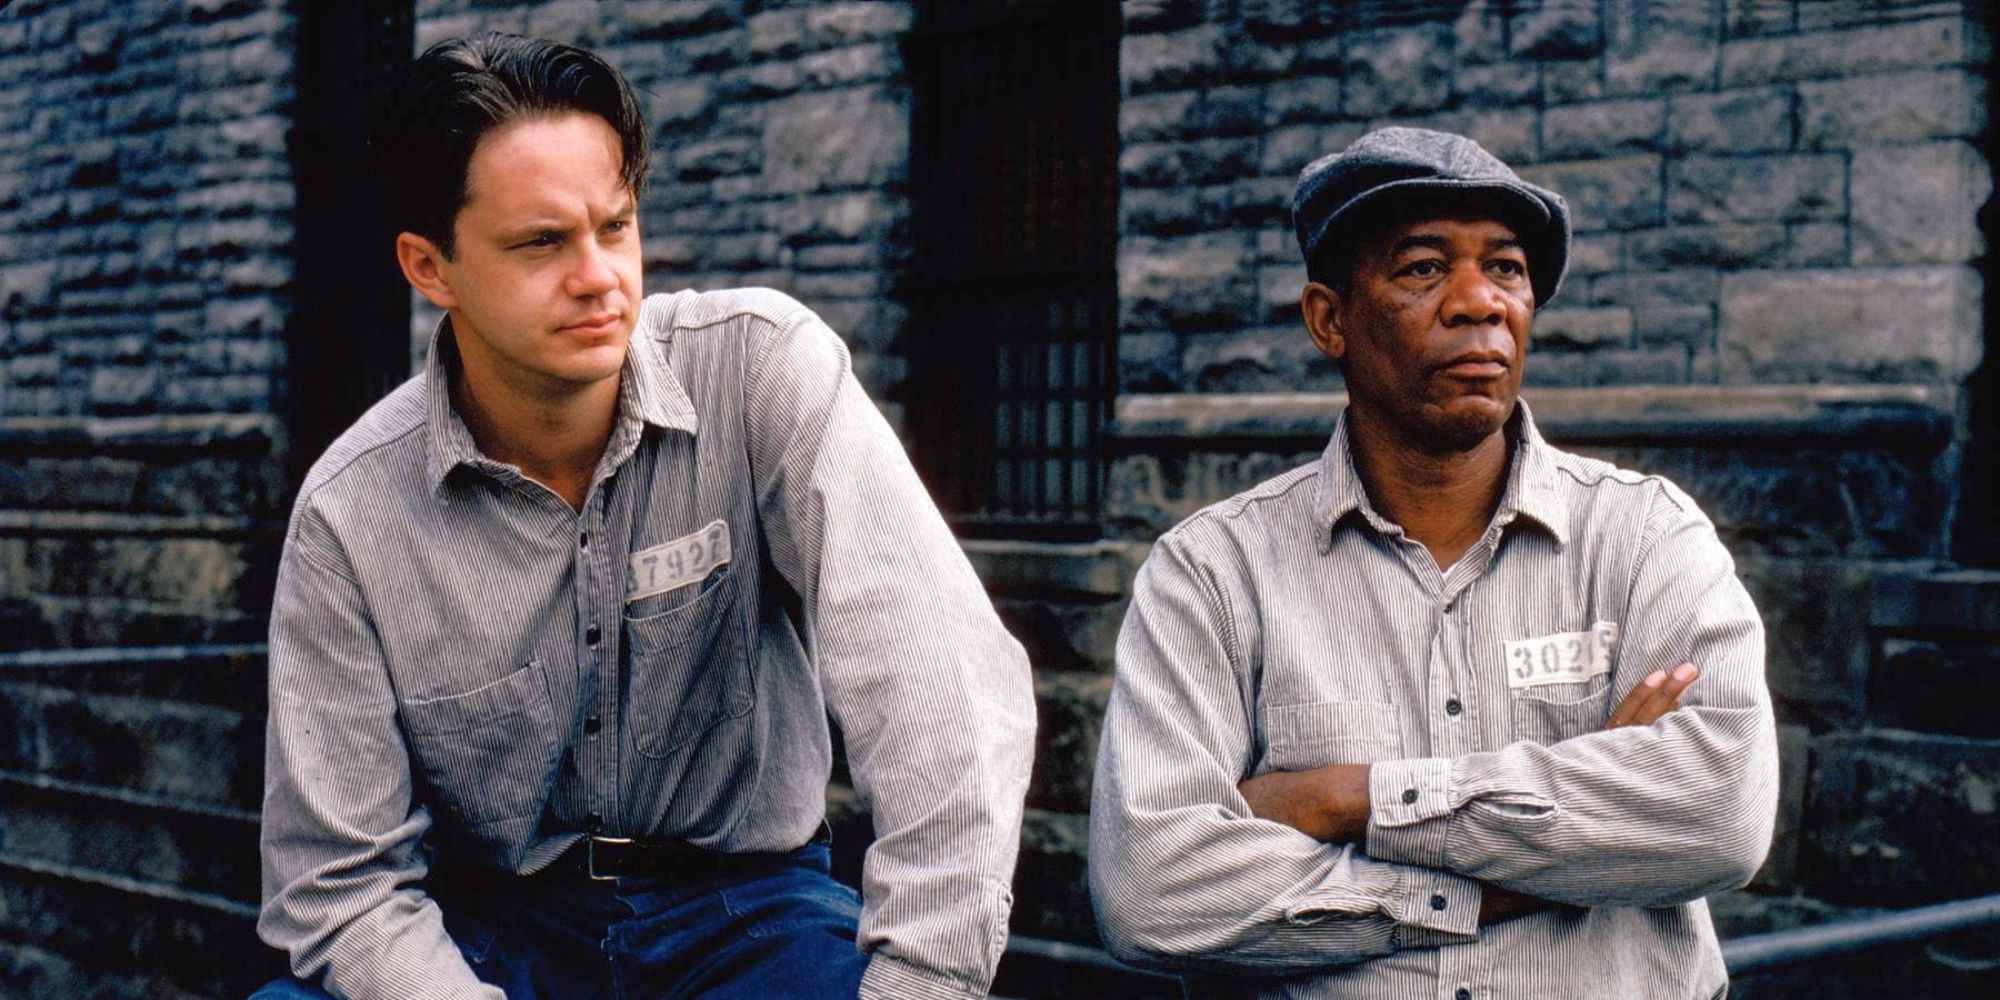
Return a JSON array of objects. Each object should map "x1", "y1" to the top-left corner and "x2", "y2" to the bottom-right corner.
[{"x1": 258, "y1": 508, "x2": 500, "y2": 1000}]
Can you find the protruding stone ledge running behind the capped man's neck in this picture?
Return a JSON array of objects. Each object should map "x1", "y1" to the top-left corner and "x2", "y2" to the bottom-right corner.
[{"x1": 1108, "y1": 384, "x2": 1956, "y2": 452}]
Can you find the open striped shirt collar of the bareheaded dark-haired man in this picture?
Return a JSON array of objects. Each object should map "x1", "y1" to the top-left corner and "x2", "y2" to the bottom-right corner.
[{"x1": 424, "y1": 308, "x2": 698, "y2": 492}]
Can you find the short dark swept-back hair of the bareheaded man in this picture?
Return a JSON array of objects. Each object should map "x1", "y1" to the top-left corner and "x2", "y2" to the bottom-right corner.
[{"x1": 376, "y1": 32, "x2": 652, "y2": 258}]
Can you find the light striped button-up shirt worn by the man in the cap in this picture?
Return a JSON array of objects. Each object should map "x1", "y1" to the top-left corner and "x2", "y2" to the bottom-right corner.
[{"x1": 1090, "y1": 404, "x2": 1778, "y2": 1000}]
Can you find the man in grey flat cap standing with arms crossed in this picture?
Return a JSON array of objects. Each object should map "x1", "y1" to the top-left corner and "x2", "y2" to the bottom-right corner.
[{"x1": 1090, "y1": 128, "x2": 1778, "y2": 1000}]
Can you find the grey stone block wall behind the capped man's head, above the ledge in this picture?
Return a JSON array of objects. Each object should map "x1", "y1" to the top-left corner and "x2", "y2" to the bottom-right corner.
[{"x1": 1120, "y1": 0, "x2": 1992, "y2": 392}]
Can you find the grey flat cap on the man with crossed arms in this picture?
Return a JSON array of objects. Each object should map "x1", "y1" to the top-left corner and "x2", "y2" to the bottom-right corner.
[{"x1": 1292, "y1": 128, "x2": 1570, "y2": 308}]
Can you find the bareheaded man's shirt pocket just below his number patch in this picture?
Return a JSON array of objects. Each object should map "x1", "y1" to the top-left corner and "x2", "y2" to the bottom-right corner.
[{"x1": 624, "y1": 570, "x2": 752, "y2": 758}]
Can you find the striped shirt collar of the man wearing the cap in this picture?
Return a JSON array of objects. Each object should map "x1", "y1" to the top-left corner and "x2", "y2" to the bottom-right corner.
[{"x1": 1314, "y1": 400, "x2": 1570, "y2": 550}]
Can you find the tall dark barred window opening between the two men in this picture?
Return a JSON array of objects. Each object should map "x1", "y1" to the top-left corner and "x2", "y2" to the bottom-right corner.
[{"x1": 904, "y1": 0, "x2": 1120, "y2": 538}]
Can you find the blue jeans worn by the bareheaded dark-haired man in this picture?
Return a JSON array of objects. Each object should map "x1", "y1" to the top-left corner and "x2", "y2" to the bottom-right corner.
[{"x1": 250, "y1": 844, "x2": 866, "y2": 1000}]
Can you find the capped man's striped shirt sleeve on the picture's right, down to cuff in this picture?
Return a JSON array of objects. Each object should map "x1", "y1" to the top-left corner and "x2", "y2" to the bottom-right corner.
[{"x1": 1368, "y1": 484, "x2": 1778, "y2": 906}]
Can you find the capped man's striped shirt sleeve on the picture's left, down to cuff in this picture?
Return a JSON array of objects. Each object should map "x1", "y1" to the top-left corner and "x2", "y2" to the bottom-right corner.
[{"x1": 1090, "y1": 534, "x2": 1480, "y2": 976}]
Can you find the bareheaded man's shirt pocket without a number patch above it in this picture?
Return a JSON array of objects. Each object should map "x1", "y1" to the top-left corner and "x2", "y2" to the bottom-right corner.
[{"x1": 402, "y1": 660, "x2": 556, "y2": 828}]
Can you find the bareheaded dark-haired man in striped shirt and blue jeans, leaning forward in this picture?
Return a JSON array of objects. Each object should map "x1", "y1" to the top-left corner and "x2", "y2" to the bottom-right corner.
[{"x1": 258, "y1": 34, "x2": 1034, "y2": 1000}]
